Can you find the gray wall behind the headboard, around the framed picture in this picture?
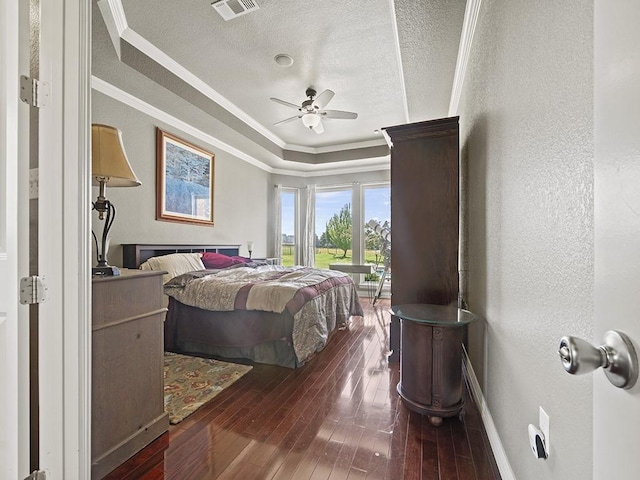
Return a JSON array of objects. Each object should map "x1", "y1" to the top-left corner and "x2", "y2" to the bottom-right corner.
[{"x1": 92, "y1": 91, "x2": 270, "y2": 266}]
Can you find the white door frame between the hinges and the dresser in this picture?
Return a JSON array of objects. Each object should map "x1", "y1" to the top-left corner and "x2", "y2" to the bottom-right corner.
[{"x1": 36, "y1": 0, "x2": 91, "y2": 480}]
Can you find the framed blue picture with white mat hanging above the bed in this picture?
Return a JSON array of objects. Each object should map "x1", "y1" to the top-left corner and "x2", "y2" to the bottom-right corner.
[{"x1": 156, "y1": 128, "x2": 214, "y2": 225}]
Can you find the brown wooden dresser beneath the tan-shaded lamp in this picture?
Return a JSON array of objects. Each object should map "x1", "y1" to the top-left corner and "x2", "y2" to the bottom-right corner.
[{"x1": 91, "y1": 269, "x2": 169, "y2": 480}]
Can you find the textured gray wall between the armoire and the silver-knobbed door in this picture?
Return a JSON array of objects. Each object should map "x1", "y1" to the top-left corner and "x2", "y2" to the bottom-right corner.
[{"x1": 460, "y1": 0, "x2": 593, "y2": 480}]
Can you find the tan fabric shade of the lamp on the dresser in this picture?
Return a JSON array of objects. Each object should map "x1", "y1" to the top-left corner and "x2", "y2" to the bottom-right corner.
[{"x1": 91, "y1": 123, "x2": 142, "y2": 187}]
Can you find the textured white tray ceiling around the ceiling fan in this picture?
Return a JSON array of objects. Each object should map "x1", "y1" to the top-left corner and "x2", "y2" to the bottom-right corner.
[{"x1": 100, "y1": 0, "x2": 466, "y2": 165}]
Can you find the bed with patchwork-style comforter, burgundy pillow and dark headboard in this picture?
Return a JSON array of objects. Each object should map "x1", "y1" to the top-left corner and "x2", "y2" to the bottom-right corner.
[{"x1": 123, "y1": 244, "x2": 362, "y2": 368}]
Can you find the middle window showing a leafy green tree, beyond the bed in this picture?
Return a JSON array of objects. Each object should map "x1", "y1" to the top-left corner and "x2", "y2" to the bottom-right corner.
[{"x1": 315, "y1": 187, "x2": 358, "y2": 268}]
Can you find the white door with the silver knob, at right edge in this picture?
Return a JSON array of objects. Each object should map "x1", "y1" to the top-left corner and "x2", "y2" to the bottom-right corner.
[{"x1": 585, "y1": 0, "x2": 640, "y2": 480}]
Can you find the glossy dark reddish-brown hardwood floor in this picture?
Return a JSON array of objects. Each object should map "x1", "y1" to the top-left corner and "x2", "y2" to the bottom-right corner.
[{"x1": 107, "y1": 298, "x2": 500, "y2": 480}]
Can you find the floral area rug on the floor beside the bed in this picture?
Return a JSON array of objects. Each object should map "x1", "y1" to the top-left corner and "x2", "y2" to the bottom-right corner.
[{"x1": 164, "y1": 352, "x2": 253, "y2": 425}]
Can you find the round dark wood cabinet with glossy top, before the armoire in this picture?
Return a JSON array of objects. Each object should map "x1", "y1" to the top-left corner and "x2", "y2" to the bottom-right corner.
[{"x1": 391, "y1": 303, "x2": 478, "y2": 426}]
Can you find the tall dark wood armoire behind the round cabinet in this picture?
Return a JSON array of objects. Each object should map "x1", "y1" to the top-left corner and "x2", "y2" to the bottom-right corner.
[{"x1": 385, "y1": 117, "x2": 460, "y2": 362}]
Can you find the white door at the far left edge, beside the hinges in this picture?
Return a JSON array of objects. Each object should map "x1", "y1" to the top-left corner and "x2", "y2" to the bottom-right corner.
[{"x1": 0, "y1": 0, "x2": 29, "y2": 480}]
